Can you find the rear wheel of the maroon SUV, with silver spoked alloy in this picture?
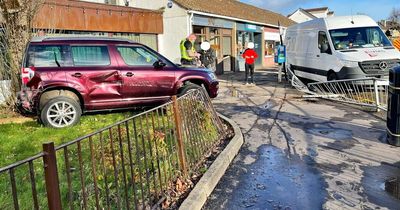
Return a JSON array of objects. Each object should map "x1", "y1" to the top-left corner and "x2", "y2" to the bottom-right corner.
[{"x1": 40, "y1": 96, "x2": 82, "y2": 128}]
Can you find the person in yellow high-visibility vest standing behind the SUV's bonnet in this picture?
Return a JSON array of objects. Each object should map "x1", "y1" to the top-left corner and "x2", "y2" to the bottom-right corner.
[{"x1": 179, "y1": 34, "x2": 198, "y2": 65}]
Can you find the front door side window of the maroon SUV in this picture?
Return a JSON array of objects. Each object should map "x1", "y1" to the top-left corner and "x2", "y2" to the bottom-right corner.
[{"x1": 117, "y1": 46, "x2": 160, "y2": 66}]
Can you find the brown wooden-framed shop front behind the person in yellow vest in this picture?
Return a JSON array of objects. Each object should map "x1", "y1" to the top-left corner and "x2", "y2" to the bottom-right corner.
[{"x1": 192, "y1": 15, "x2": 235, "y2": 70}]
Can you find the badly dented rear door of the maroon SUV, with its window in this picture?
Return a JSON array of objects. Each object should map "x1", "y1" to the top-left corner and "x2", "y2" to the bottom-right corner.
[{"x1": 66, "y1": 45, "x2": 122, "y2": 106}]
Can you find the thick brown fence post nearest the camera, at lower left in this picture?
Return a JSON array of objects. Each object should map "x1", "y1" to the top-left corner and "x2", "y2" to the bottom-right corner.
[{"x1": 43, "y1": 142, "x2": 62, "y2": 210}]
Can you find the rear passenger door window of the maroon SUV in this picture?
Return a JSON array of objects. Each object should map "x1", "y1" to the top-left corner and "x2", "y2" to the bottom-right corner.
[{"x1": 71, "y1": 46, "x2": 110, "y2": 66}]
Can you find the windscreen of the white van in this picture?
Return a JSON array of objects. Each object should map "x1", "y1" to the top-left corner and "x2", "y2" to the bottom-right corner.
[{"x1": 329, "y1": 27, "x2": 391, "y2": 50}]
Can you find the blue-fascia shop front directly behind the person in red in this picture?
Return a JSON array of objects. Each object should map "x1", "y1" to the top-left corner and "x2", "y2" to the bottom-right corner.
[{"x1": 236, "y1": 23, "x2": 264, "y2": 71}]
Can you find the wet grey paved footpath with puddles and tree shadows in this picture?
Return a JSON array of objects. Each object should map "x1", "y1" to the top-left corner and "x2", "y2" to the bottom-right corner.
[{"x1": 203, "y1": 70, "x2": 400, "y2": 210}]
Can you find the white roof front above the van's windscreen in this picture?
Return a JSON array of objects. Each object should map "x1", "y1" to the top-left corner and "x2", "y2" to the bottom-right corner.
[{"x1": 325, "y1": 15, "x2": 378, "y2": 30}]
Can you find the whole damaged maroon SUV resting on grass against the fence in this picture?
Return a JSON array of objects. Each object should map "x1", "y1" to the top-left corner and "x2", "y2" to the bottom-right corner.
[{"x1": 19, "y1": 37, "x2": 218, "y2": 128}]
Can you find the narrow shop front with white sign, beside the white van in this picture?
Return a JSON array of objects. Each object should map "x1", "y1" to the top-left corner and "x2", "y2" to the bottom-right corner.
[{"x1": 264, "y1": 27, "x2": 280, "y2": 67}]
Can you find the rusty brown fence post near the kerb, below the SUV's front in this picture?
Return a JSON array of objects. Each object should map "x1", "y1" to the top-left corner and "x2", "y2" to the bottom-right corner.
[{"x1": 172, "y1": 96, "x2": 187, "y2": 176}]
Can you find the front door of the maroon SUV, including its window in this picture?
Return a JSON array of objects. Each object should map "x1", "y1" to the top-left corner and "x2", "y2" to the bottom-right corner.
[{"x1": 116, "y1": 45, "x2": 175, "y2": 100}]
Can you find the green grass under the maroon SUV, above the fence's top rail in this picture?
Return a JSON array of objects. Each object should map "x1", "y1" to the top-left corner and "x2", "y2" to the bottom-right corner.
[{"x1": 0, "y1": 111, "x2": 137, "y2": 168}]
